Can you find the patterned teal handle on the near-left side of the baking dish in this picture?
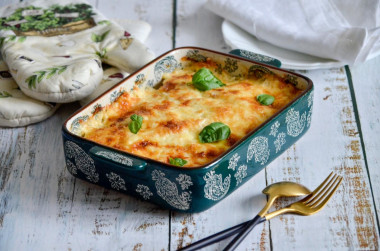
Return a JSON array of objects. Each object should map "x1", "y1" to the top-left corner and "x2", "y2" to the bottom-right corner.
[{"x1": 89, "y1": 146, "x2": 147, "y2": 171}]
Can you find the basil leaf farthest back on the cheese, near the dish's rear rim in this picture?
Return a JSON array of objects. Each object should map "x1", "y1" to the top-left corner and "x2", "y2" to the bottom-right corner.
[{"x1": 193, "y1": 68, "x2": 225, "y2": 91}]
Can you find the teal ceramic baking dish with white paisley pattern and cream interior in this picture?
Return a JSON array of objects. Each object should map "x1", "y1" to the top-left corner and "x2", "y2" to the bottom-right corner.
[{"x1": 62, "y1": 47, "x2": 313, "y2": 212}]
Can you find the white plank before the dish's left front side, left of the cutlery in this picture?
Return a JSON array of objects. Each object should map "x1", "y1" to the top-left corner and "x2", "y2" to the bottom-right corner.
[{"x1": 61, "y1": 180, "x2": 168, "y2": 250}]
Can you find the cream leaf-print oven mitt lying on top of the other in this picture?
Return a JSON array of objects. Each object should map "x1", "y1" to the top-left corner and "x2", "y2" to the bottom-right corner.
[{"x1": 0, "y1": 0, "x2": 154, "y2": 103}]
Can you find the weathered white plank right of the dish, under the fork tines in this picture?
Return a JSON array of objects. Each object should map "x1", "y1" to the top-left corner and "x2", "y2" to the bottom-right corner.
[{"x1": 267, "y1": 68, "x2": 378, "y2": 250}]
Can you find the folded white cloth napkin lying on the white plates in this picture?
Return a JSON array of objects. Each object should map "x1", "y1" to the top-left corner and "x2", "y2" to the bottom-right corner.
[{"x1": 206, "y1": 0, "x2": 380, "y2": 64}]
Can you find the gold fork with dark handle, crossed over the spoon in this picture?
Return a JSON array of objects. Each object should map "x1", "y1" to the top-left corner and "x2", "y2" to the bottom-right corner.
[{"x1": 224, "y1": 173, "x2": 343, "y2": 250}]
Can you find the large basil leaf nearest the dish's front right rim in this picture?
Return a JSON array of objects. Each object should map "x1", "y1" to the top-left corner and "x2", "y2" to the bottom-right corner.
[{"x1": 198, "y1": 122, "x2": 231, "y2": 143}]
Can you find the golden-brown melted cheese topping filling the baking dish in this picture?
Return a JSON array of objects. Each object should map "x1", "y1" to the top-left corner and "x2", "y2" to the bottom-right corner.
[{"x1": 80, "y1": 59, "x2": 301, "y2": 167}]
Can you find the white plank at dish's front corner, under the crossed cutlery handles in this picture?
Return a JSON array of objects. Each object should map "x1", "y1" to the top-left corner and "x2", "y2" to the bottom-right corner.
[{"x1": 171, "y1": 170, "x2": 270, "y2": 250}]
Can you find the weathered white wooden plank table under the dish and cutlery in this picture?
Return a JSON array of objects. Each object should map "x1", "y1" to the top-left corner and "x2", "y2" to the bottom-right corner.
[{"x1": 0, "y1": 0, "x2": 380, "y2": 250}]
